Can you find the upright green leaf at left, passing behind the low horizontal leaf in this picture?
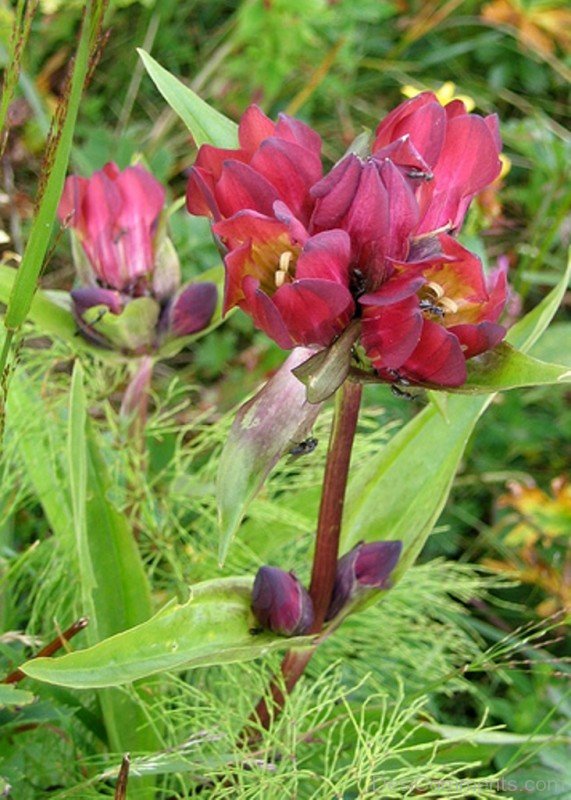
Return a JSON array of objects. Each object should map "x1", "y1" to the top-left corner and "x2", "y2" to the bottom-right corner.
[{"x1": 67, "y1": 362, "x2": 161, "y2": 776}]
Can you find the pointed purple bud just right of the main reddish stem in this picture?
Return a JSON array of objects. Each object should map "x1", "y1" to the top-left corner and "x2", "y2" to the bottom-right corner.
[{"x1": 326, "y1": 542, "x2": 402, "y2": 620}]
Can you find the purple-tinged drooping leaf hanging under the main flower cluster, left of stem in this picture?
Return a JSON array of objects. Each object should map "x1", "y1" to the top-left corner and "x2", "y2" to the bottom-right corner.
[{"x1": 216, "y1": 347, "x2": 321, "y2": 562}]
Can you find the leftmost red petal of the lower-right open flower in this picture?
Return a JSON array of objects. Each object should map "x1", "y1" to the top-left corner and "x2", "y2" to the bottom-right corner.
[{"x1": 362, "y1": 296, "x2": 423, "y2": 369}]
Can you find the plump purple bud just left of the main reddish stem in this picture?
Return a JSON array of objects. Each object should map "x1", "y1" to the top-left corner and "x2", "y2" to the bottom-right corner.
[{"x1": 252, "y1": 567, "x2": 313, "y2": 636}]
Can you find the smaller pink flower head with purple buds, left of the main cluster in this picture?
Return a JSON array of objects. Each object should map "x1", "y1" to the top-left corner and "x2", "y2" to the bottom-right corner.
[{"x1": 58, "y1": 163, "x2": 216, "y2": 354}]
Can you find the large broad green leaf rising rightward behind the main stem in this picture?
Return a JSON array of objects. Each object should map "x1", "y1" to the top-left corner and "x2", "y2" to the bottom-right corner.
[{"x1": 341, "y1": 253, "x2": 571, "y2": 579}]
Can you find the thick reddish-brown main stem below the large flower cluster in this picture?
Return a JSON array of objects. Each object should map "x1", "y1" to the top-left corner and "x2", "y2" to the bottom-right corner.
[{"x1": 245, "y1": 381, "x2": 362, "y2": 743}]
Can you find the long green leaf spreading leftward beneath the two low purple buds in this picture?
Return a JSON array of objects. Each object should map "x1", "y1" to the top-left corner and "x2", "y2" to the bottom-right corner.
[{"x1": 22, "y1": 578, "x2": 308, "y2": 689}]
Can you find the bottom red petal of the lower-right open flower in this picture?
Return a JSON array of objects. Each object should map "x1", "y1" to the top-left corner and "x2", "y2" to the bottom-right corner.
[{"x1": 400, "y1": 320, "x2": 466, "y2": 386}]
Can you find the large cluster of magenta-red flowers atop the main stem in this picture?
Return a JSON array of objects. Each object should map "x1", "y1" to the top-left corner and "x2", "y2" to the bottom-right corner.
[{"x1": 187, "y1": 92, "x2": 507, "y2": 387}]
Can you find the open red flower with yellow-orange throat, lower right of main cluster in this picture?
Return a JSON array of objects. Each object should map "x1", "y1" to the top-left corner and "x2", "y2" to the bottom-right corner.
[{"x1": 359, "y1": 234, "x2": 506, "y2": 387}]
